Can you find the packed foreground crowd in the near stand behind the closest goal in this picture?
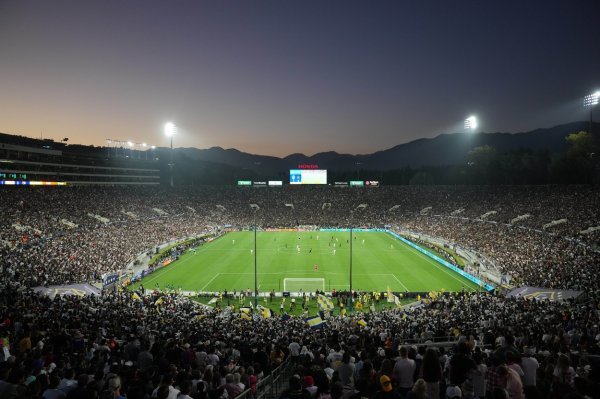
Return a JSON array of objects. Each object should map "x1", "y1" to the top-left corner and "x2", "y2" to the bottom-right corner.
[{"x1": 0, "y1": 282, "x2": 600, "y2": 399}]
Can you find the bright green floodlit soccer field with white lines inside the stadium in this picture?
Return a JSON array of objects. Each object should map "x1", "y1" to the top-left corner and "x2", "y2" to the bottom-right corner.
[{"x1": 132, "y1": 231, "x2": 479, "y2": 292}]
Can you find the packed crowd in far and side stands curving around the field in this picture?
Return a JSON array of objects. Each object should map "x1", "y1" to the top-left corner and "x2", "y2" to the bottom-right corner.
[{"x1": 0, "y1": 186, "x2": 600, "y2": 290}]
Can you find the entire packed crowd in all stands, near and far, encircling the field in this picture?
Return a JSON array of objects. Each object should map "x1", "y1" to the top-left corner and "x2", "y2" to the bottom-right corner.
[{"x1": 0, "y1": 187, "x2": 600, "y2": 399}]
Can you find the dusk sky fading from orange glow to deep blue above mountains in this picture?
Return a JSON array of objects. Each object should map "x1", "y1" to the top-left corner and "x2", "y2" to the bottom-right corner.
[{"x1": 0, "y1": 0, "x2": 600, "y2": 156}]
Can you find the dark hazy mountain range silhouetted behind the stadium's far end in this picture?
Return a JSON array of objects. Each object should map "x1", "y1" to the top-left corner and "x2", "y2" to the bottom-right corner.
[{"x1": 176, "y1": 122, "x2": 600, "y2": 176}]
